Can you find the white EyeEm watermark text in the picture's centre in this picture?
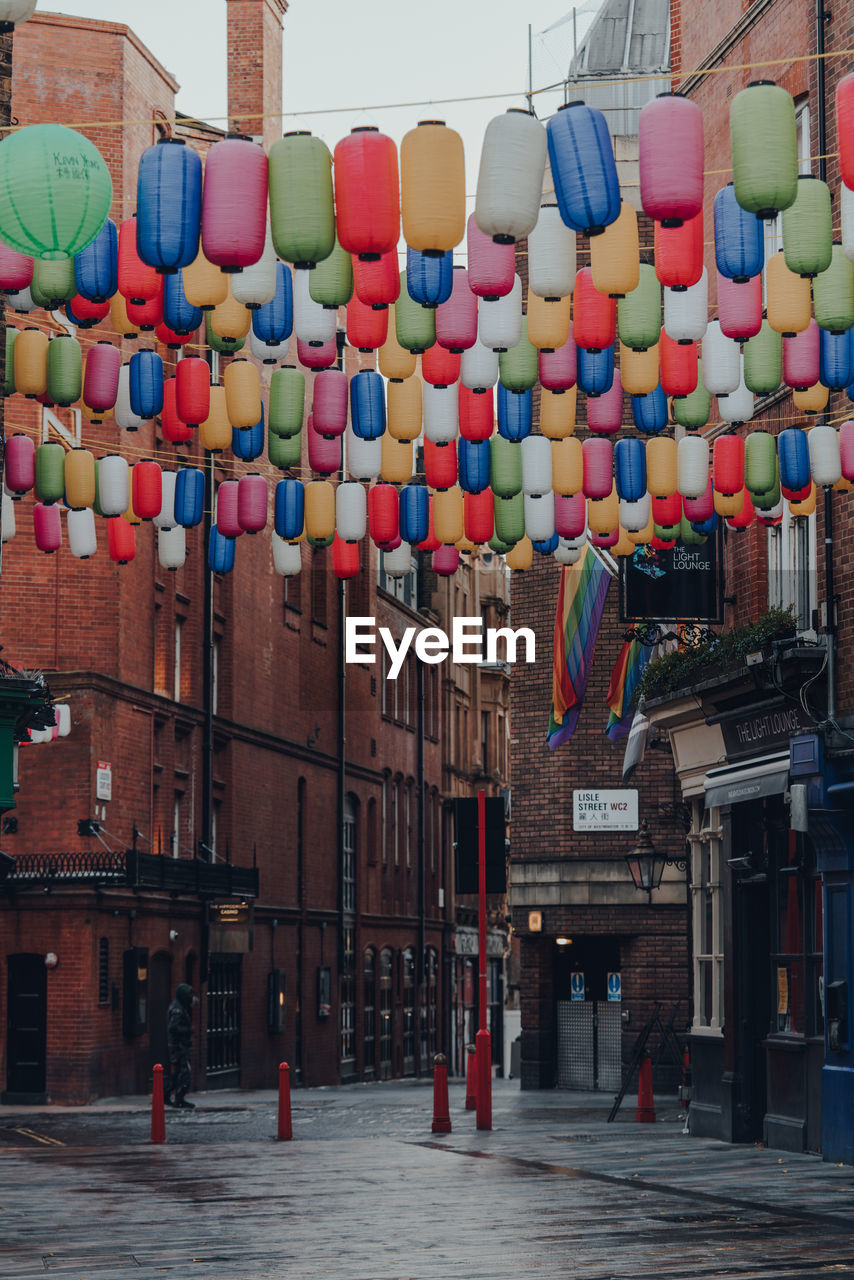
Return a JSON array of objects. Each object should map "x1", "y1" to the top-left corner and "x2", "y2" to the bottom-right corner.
[{"x1": 344, "y1": 617, "x2": 535, "y2": 680}]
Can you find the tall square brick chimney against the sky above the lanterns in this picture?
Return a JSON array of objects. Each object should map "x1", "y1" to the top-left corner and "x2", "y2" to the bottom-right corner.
[{"x1": 225, "y1": 0, "x2": 288, "y2": 148}]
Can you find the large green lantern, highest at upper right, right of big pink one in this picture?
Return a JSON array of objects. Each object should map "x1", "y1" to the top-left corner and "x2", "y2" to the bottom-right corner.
[{"x1": 730, "y1": 81, "x2": 798, "y2": 218}]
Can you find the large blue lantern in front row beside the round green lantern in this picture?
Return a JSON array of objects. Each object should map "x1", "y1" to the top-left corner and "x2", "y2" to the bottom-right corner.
[{"x1": 137, "y1": 138, "x2": 201, "y2": 273}]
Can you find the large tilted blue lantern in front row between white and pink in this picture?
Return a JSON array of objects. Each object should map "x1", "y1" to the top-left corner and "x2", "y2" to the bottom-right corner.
[{"x1": 545, "y1": 102, "x2": 620, "y2": 236}]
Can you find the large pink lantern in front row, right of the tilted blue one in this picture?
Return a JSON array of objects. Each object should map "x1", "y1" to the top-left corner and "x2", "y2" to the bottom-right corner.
[{"x1": 638, "y1": 93, "x2": 704, "y2": 224}]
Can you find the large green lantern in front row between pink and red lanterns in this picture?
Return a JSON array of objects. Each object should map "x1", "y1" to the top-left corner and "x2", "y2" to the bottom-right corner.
[{"x1": 268, "y1": 131, "x2": 335, "y2": 266}]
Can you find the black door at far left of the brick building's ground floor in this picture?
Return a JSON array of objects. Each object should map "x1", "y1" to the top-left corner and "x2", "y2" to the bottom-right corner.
[{"x1": 4, "y1": 955, "x2": 47, "y2": 1102}]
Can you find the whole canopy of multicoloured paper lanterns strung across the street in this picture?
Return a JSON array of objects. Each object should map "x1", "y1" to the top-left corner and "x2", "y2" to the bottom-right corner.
[{"x1": 0, "y1": 76, "x2": 854, "y2": 577}]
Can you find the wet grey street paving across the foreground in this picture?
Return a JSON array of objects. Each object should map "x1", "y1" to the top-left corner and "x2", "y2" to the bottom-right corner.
[{"x1": 0, "y1": 1080, "x2": 854, "y2": 1280}]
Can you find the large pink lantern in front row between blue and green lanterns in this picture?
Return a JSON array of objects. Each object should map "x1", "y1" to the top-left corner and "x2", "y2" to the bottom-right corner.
[{"x1": 201, "y1": 138, "x2": 268, "y2": 271}]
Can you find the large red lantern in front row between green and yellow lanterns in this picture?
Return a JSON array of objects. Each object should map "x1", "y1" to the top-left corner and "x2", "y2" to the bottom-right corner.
[{"x1": 334, "y1": 125, "x2": 401, "y2": 259}]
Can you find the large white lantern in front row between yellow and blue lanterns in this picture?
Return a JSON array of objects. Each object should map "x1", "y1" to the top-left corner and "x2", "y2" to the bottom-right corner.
[{"x1": 475, "y1": 108, "x2": 545, "y2": 243}]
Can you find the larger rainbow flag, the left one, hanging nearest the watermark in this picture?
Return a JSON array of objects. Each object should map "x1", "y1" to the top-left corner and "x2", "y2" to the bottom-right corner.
[{"x1": 548, "y1": 547, "x2": 611, "y2": 750}]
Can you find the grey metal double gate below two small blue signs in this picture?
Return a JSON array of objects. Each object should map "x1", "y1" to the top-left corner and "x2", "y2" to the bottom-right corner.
[{"x1": 557, "y1": 1000, "x2": 622, "y2": 1092}]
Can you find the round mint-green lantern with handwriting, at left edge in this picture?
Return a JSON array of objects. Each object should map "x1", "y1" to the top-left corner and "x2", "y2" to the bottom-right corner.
[{"x1": 0, "y1": 124, "x2": 113, "y2": 259}]
